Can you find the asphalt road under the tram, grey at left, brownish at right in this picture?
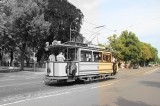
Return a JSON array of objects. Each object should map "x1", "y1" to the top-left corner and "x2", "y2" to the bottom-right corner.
[{"x1": 0, "y1": 67, "x2": 160, "y2": 106}]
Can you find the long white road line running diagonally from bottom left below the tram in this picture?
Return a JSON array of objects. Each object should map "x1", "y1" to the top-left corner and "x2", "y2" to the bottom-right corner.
[{"x1": 0, "y1": 80, "x2": 120, "y2": 106}]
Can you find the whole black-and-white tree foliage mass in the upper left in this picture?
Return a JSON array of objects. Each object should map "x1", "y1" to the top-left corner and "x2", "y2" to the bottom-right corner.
[{"x1": 0, "y1": 0, "x2": 83, "y2": 70}]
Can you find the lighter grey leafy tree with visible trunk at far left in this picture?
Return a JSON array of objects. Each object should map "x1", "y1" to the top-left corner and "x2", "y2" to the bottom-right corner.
[{"x1": 0, "y1": 0, "x2": 50, "y2": 70}]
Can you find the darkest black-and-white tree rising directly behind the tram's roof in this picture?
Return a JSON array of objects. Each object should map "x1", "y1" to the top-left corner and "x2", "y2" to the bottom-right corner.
[{"x1": 45, "y1": 0, "x2": 84, "y2": 43}]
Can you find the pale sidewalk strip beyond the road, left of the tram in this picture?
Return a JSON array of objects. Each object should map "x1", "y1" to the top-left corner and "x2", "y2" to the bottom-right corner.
[{"x1": 0, "y1": 66, "x2": 45, "y2": 73}]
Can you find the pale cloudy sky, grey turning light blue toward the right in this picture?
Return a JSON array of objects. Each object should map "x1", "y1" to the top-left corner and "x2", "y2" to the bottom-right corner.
[{"x1": 68, "y1": 0, "x2": 160, "y2": 57}]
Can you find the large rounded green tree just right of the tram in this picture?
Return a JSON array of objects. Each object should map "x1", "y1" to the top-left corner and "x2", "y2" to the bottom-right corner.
[{"x1": 108, "y1": 31, "x2": 140, "y2": 63}]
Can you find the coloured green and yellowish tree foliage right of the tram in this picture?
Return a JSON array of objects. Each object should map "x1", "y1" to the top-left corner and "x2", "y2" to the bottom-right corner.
[{"x1": 108, "y1": 31, "x2": 158, "y2": 63}]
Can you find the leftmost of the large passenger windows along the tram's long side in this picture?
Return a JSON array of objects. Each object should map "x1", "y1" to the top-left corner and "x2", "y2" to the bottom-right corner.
[{"x1": 81, "y1": 51, "x2": 92, "y2": 62}]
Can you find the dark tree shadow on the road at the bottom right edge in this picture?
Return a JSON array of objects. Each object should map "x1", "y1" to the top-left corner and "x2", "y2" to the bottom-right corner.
[{"x1": 115, "y1": 97, "x2": 153, "y2": 106}]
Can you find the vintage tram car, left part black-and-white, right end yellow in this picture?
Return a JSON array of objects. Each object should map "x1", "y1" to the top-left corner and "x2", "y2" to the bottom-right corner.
[{"x1": 44, "y1": 42, "x2": 118, "y2": 84}]
